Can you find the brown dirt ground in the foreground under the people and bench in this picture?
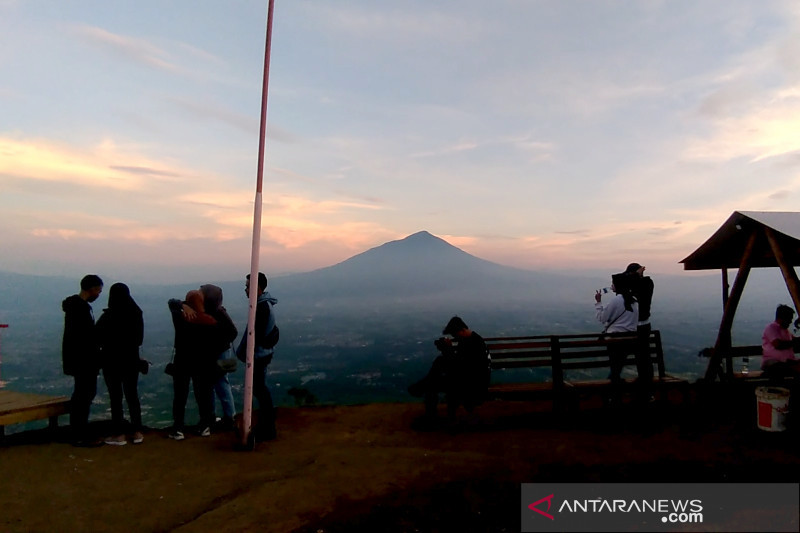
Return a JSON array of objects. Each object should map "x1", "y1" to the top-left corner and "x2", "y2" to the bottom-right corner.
[{"x1": 0, "y1": 390, "x2": 800, "y2": 532}]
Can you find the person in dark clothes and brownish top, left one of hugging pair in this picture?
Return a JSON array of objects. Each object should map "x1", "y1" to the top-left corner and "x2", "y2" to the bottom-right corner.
[{"x1": 167, "y1": 290, "x2": 230, "y2": 440}]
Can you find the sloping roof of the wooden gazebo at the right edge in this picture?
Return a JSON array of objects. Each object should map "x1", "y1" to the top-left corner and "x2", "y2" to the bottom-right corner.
[{"x1": 681, "y1": 211, "x2": 800, "y2": 270}]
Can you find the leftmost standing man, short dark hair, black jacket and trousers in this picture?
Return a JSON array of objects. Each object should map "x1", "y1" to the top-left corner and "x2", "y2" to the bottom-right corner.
[{"x1": 61, "y1": 274, "x2": 103, "y2": 446}]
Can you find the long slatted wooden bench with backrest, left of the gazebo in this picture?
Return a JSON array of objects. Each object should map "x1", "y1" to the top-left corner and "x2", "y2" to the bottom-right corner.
[{"x1": 484, "y1": 330, "x2": 688, "y2": 410}]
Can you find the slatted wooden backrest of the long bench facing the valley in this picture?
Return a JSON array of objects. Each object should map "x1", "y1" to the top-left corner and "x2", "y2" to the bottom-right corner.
[{"x1": 484, "y1": 330, "x2": 666, "y2": 382}]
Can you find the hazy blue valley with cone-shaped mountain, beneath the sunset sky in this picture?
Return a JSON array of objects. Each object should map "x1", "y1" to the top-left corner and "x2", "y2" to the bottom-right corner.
[{"x1": 0, "y1": 232, "x2": 791, "y2": 431}]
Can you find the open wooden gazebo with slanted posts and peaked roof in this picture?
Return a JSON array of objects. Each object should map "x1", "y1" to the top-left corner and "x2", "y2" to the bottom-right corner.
[{"x1": 681, "y1": 211, "x2": 800, "y2": 381}]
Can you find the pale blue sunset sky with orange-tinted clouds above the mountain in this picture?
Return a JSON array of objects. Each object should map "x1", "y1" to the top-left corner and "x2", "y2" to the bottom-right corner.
[{"x1": 0, "y1": 0, "x2": 800, "y2": 282}]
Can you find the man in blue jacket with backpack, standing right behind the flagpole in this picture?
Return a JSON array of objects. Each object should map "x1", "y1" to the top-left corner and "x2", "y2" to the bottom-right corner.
[{"x1": 236, "y1": 272, "x2": 278, "y2": 442}]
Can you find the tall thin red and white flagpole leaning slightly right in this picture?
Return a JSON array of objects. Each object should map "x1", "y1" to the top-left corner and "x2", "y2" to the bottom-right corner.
[{"x1": 242, "y1": 0, "x2": 275, "y2": 446}]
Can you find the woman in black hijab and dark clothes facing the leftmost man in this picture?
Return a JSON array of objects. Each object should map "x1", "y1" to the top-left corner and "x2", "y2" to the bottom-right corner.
[{"x1": 96, "y1": 283, "x2": 144, "y2": 446}]
